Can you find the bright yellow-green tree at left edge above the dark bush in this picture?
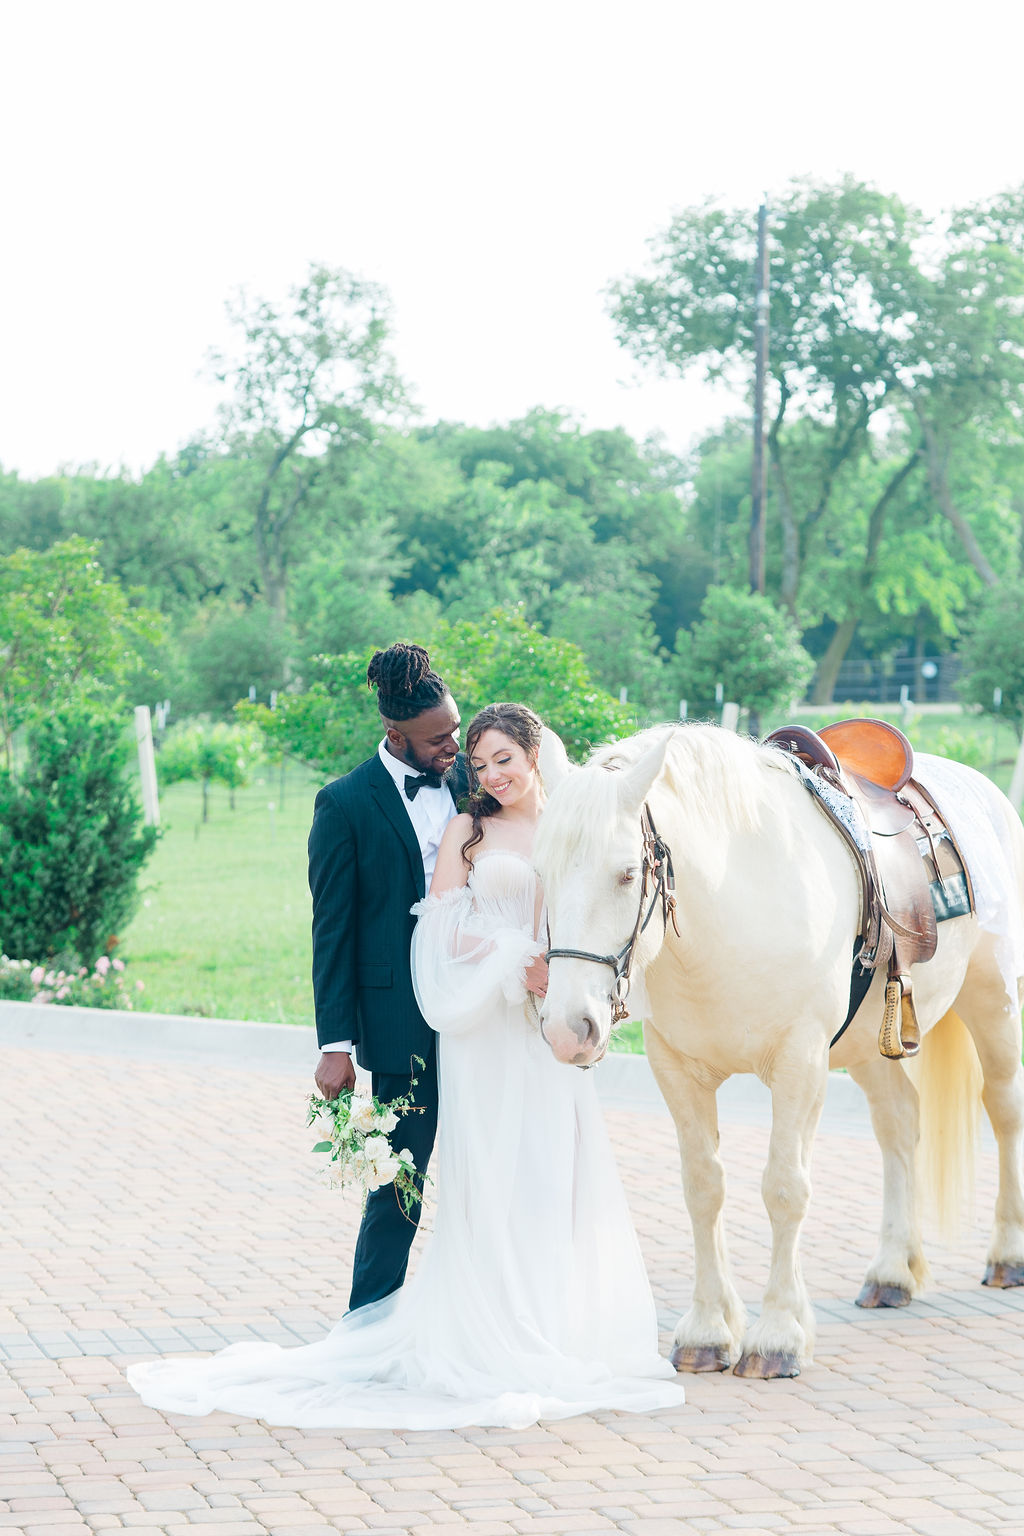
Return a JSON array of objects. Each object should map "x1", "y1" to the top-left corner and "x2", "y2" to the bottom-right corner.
[{"x1": 0, "y1": 538, "x2": 161, "y2": 768}]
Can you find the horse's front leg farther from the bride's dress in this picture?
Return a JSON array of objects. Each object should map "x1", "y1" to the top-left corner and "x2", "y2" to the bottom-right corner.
[{"x1": 735, "y1": 1034, "x2": 829, "y2": 1379}]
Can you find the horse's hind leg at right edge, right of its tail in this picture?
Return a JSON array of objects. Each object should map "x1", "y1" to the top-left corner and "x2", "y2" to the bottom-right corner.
[{"x1": 955, "y1": 958, "x2": 1024, "y2": 1287}]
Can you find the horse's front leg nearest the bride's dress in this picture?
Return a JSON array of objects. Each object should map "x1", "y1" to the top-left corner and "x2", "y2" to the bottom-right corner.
[{"x1": 645, "y1": 1028, "x2": 746, "y2": 1372}]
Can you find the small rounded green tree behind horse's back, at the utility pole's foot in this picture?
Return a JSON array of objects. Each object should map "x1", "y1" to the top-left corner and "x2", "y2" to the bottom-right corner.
[{"x1": 676, "y1": 587, "x2": 814, "y2": 714}]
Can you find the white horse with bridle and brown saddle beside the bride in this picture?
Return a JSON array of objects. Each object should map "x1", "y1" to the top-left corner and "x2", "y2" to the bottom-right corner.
[{"x1": 534, "y1": 725, "x2": 1024, "y2": 1376}]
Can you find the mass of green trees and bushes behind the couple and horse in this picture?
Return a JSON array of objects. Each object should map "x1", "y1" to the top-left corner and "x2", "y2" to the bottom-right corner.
[{"x1": 0, "y1": 178, "x2": 1024, "y2": 1017}]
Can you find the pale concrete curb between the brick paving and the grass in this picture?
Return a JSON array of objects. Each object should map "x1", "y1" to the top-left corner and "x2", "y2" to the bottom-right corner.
[{"x1": 0, "y1": 1001, "x2": 869, "y2": 1134}]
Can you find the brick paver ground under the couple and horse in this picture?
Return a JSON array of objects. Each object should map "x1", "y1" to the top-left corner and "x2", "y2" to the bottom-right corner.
[{"x1": 0, "y1": 1048, "x2": 1024, "y2": 1536}]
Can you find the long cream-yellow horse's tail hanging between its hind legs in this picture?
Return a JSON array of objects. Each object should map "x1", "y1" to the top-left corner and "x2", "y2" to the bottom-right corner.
[{"x1": 912, "y1": 1008, "x2": 983, "y2": 1236}]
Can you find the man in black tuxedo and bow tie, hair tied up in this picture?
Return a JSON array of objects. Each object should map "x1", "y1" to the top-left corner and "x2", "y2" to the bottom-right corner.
[{"x1": 309, "y1": 644, "x2": 467, "y2": 1307}]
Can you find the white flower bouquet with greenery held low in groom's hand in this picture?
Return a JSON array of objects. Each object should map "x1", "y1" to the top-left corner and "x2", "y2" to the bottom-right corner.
[{"x1": 307, "y1": 1056, "x2": 422, "y2": 1215}]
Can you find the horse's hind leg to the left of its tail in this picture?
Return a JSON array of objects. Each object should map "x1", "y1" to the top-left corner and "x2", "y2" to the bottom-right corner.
[{"x1": 849, "y1": 1055, "x2": 927, "y2": 1307}]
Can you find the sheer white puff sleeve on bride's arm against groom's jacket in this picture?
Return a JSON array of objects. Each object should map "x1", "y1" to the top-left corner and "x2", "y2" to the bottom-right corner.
[{"x1": 411, "y1": 886, "x2": 545, "y2": 1034}]
